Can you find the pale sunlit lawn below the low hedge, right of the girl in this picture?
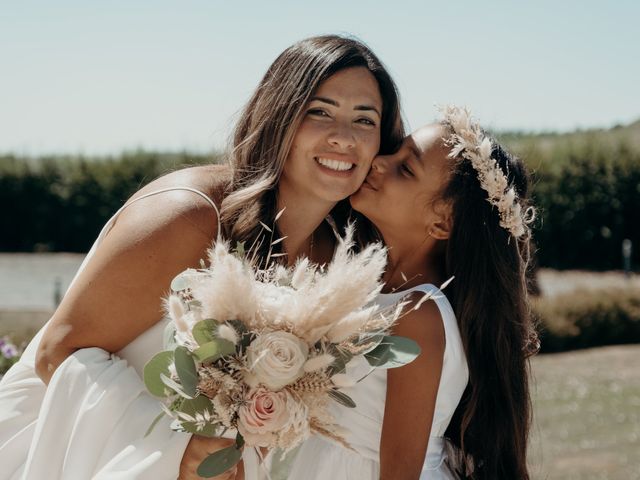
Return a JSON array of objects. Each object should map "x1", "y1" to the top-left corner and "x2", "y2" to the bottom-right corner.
[{"x1": 529, "y1": 345, "x2": 640, "y2": 480}]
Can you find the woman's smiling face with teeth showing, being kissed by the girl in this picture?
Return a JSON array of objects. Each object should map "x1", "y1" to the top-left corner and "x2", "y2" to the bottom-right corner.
[{"x1": 279, "y1": 67, "x2": 382, "y2": 203}]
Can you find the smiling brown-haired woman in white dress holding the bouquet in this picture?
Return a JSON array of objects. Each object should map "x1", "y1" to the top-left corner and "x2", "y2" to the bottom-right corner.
[{"x1": 0, "y1": 36, "x2": 403, "y2": 480}]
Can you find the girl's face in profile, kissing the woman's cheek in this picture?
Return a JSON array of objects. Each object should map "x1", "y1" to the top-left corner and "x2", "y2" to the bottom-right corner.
[{"x1": 350, "y1": 124, "x2": 452, "y2": 238}]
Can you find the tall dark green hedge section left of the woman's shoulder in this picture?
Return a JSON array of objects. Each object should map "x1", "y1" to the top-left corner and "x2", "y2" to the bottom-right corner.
[{"x1": 0, "y1": 152, "x2": 218, "y2": 252}]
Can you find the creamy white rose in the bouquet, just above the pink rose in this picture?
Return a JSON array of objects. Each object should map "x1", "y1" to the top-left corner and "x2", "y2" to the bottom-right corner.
[{"x1": 247, "y1": 331, "x2": 309, "y2": 390}]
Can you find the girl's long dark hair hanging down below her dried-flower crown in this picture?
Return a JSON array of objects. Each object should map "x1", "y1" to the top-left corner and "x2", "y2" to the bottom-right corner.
[{"x1": 443, "y1": 137, "x2": 538, "y2": 480}]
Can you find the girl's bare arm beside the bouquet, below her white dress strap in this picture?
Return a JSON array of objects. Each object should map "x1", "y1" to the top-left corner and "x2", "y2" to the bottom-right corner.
[{"x1": 380, "y1": 301, "x2": 445, "y2": 480}]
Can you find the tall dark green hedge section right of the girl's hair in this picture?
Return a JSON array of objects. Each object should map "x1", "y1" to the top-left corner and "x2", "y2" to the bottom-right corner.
[{"x1": 529, "y1": 144, "x2": 640, "y2": 270}]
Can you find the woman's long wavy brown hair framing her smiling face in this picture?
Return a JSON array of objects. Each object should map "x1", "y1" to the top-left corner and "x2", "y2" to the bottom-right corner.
[{"x1": 221, "y1": 35, "x2": 404, "y2": 255}]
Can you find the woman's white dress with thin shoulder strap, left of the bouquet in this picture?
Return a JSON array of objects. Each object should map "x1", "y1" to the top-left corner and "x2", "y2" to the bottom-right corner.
[{"x1": 0, "y1": 187, "x2": 257, "y2": 480}]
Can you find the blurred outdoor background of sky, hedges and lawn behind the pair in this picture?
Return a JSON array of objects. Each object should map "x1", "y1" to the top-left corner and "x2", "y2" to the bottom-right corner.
[{"x1": 0, "y1": 0, "x2": 640, "y2": 479}]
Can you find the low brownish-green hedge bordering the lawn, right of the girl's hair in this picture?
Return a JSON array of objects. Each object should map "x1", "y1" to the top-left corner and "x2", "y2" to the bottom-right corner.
[{"x1": 533, "y1": 287, "x2": 640, "y2": 353}]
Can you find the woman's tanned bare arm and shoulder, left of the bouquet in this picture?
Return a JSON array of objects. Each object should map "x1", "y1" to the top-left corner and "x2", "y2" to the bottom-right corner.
[{"x1": 36, "y1": 186, "x2": 217, "y2": 383}]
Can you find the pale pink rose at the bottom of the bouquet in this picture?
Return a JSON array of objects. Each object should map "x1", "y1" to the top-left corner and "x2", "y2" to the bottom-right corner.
[{"x1": 238, "y1": 387, "x2": 289, "y2": 447}]
